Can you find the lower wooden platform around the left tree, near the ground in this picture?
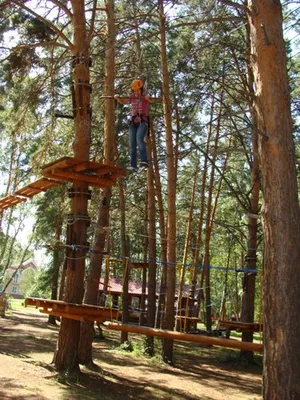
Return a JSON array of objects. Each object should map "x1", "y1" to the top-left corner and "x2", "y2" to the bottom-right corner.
[{"x1": 24, "y1": 297, "x2": 118, "y2": 322}]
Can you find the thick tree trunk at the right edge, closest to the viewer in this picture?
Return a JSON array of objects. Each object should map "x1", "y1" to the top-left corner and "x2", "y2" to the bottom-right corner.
[{"x1": 248, "y1": 0, "x2": 300, "y2": 400}]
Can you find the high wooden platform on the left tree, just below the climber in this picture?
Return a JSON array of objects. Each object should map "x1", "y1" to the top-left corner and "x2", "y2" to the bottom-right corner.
[{"x1": 42, "y1": 157, "x2": 126, "y2": 188}]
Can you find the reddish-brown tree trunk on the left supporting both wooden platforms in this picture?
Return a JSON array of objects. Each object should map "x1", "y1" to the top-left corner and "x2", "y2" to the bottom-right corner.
[{"x1": 53, "y1": 0, "x2": 91, "y2": 374}]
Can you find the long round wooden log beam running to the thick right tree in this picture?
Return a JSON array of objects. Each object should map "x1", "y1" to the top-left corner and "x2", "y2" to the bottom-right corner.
[{"x1": 105, "y1": 322, "x2": 263, "y2": 353}]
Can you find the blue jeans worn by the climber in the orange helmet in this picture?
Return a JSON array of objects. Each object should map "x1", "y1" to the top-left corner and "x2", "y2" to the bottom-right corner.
[{"x1": 129, "y1": 121, "x2": 148, "y2": 168}]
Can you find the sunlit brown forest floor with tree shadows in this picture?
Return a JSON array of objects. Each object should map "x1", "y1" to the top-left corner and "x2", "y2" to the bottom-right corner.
[{"x1": 0, "y1": 308, "x2": 262, "y2": 400}]
